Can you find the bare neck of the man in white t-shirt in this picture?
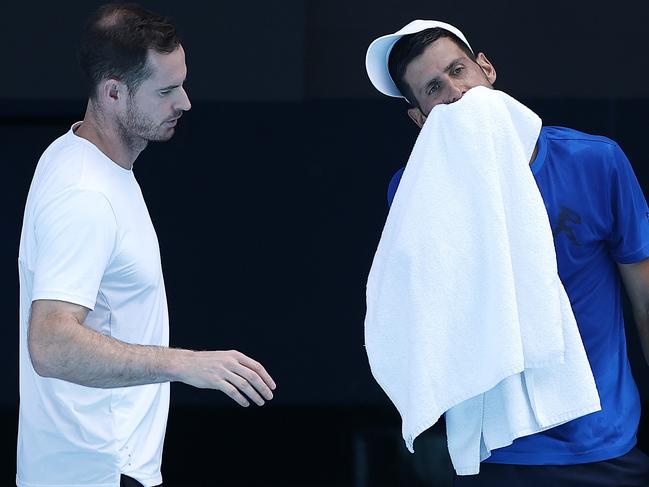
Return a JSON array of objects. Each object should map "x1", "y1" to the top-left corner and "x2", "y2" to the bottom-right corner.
[{"x1": 74, "y1": 101, "x2": 146, "y2": 170}]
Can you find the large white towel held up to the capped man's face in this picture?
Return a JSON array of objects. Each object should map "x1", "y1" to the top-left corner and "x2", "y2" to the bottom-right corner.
[{"x1": 365, "y1": 87, "x2": 600, "y2": 474}]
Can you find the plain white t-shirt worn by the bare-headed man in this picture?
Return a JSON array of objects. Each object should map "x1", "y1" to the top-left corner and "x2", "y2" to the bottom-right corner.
[{"x1": 16, "y1": 124, "x2": 169, "y2": 487}]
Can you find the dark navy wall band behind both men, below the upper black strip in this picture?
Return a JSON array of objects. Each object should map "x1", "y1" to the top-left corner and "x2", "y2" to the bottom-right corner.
[{"x1": 5, "y1": 99, "x2": 649, "y2": 405}]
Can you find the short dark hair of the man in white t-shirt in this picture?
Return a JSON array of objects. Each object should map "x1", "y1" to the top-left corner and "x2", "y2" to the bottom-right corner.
[{"x1": 79, "y1": 3, "x2": 180, "y2": 98}]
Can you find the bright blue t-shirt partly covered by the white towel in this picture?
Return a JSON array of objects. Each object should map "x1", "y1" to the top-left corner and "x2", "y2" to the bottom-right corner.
[{"x1": 388, "y1": 127, "x2": 649, "y2": 465}]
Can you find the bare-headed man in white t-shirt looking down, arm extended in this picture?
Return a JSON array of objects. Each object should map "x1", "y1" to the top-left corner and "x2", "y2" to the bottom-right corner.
[{"x1": 16, "y1": 5, "x2": 275, "y2": 487}]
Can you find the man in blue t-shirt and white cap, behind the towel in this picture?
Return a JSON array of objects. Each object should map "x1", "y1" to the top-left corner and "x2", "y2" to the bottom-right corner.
[{"x1": 366, "y1": 20, "x2": 649, "y2": 487}]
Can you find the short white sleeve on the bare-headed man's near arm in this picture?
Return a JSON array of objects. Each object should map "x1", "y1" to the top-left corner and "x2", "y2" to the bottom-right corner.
[{"x1": 32, "y1": 190, "x2": 117, "y2": 310}]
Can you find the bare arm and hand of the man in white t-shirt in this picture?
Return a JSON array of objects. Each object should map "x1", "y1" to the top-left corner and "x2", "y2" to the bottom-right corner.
[{"x1": 27, "y1": 300, "x2": 275, "y2": 406}]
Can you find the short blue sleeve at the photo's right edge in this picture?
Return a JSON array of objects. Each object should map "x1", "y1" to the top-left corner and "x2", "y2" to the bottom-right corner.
[{"x1": 608, "y1": 144, "x2": 649, "y2": 264}]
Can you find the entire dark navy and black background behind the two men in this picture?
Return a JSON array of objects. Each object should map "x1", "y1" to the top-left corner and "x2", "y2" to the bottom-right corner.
[{"x1": 0, "y1": 0, "x2": 649, "y2": 487}]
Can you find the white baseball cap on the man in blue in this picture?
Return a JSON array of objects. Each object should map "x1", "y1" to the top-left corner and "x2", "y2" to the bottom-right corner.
[{"x1": 365, "y1": 20, "x2": 473, "y2": 98}]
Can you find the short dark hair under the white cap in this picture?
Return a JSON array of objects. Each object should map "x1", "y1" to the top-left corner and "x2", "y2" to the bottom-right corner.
[{"x1": 388, "y1": 27, "x2": 476, "y2": 106}]
